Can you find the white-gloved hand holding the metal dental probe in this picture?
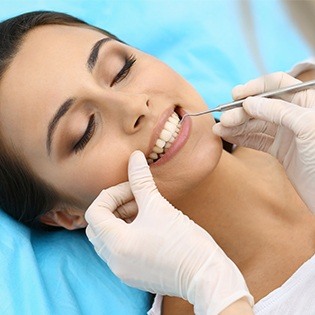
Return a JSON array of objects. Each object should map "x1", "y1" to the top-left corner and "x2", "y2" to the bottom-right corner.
[{"x1": 213, "y1": 72, "x2": 315, "y2": 213}]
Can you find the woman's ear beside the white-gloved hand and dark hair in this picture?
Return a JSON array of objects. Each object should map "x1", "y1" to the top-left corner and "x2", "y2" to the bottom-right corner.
[{"x1": 40, "y1": 208, "x2": 87, "y2": 230}]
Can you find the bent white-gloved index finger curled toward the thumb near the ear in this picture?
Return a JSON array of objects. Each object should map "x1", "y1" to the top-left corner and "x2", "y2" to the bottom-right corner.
[{"x1": 85, "y1": 182, "x2": 133, "y2": 228}]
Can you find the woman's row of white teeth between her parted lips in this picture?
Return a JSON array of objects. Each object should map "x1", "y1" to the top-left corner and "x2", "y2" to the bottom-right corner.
[{"x1": 147, "y1": 112, "x2": 181, "y2": 164}]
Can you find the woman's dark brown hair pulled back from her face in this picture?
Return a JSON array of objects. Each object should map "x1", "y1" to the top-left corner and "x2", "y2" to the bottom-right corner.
[{"x1": 0, "y1": 11, "x2": 119, "y2": 229}]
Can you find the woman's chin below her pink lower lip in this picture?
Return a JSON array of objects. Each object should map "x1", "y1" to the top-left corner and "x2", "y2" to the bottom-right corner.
[{"x1": 151, "y1": 117, "x2": 223, "y2": 204}]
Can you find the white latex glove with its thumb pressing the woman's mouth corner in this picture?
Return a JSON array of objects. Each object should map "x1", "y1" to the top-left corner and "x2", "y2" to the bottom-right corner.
[{"x1": 86, "y1": 151, "x2": 253, "y2": 315}]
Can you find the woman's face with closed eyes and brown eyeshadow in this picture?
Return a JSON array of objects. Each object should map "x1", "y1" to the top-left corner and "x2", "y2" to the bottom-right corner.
[{"x1": 0, "y1": 25, "x2": 221, "y2": 217}]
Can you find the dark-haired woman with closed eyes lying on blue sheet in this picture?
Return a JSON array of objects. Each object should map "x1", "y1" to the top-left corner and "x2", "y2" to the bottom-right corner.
[{"x1": 0, "y1": 13, "x2": 315, "y2": 314}]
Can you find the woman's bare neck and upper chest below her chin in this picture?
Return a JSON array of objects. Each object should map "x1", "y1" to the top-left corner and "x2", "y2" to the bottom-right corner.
[{"x1": 175, "y1": 149, "x2": 314, "y2": 299}]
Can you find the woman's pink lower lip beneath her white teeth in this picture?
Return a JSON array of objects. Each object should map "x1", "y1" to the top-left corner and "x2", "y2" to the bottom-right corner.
[{"x1": 150, "y1": 108, "x2": 191, "y2": 167}]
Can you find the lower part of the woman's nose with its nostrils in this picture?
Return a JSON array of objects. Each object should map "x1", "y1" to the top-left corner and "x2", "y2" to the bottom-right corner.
[{"x1": 101, "y1": 92, "x2": 150, "y2": 134}]
